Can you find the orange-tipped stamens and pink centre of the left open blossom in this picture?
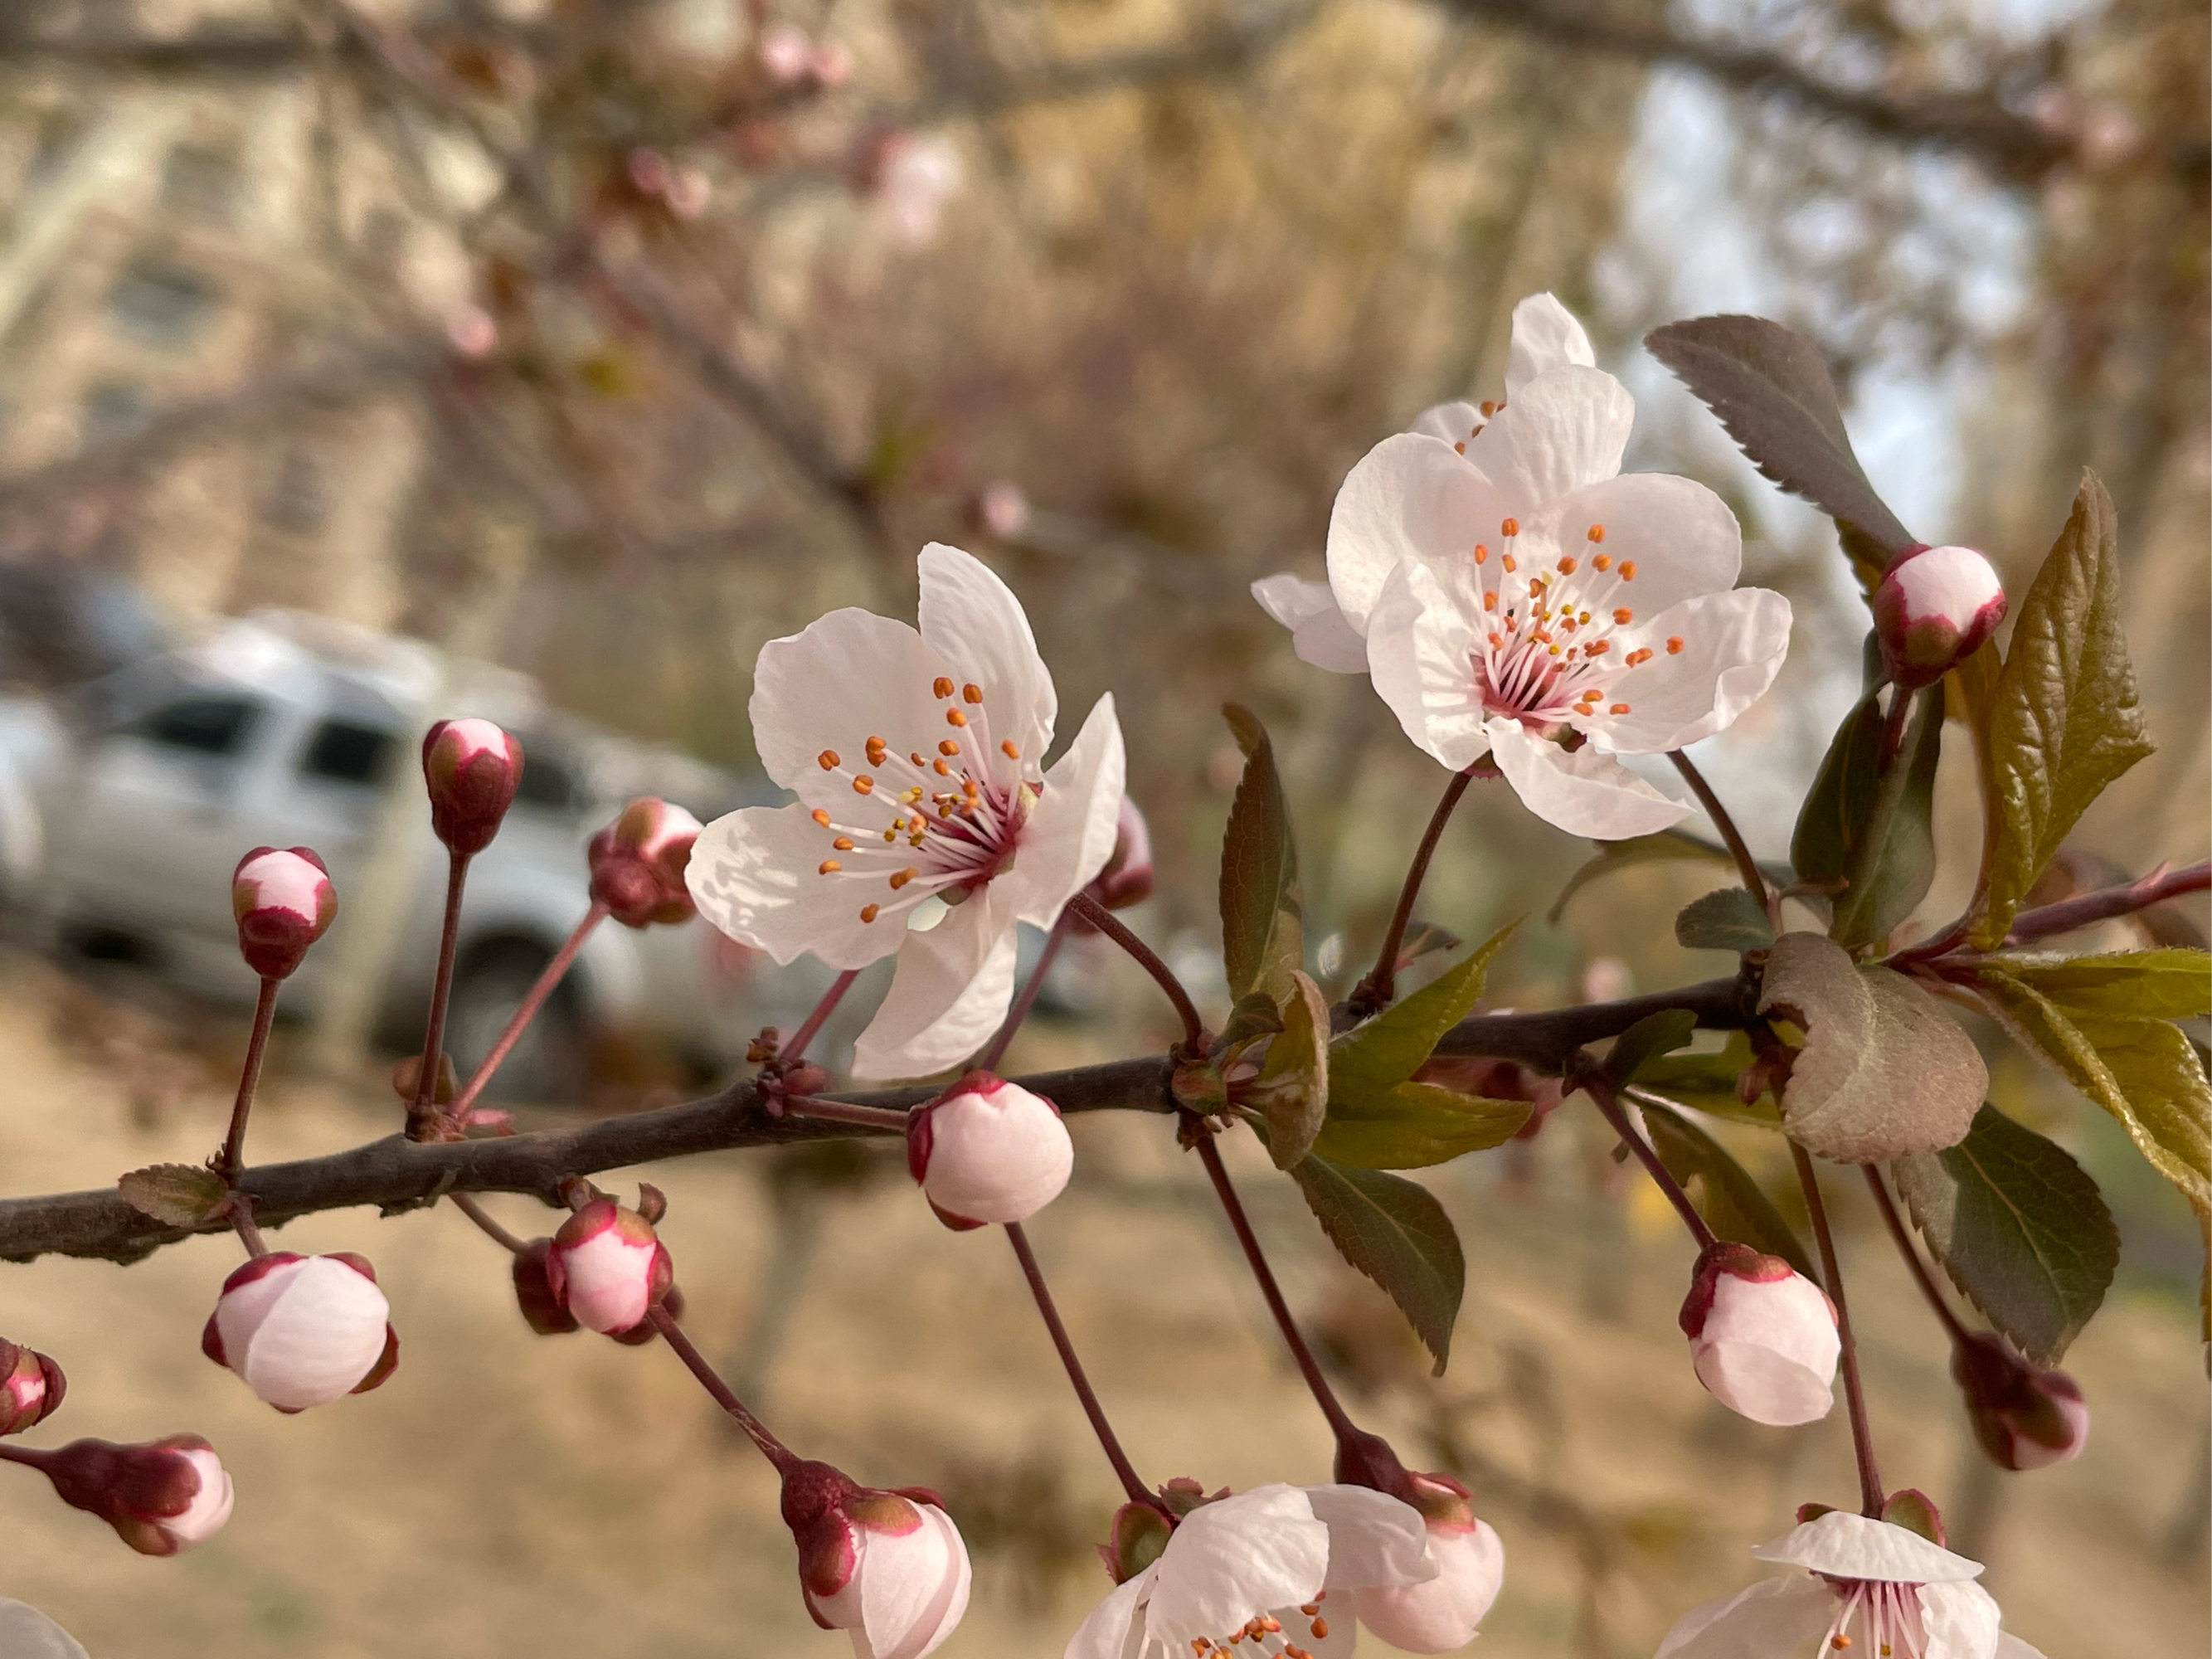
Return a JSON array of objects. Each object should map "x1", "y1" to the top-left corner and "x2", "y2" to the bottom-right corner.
[{"x1": 812, "y1": 674, "x2": 1044, "y2": 937}]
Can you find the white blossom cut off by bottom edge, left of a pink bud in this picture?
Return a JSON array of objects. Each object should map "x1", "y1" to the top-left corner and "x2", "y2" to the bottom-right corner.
[{"x1": 1066, "y1": 1484, "x2": 1438, "y2": 1659}]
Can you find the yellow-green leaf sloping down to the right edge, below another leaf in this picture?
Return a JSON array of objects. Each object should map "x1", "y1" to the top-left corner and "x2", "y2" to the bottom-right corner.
[{"x1": 1980, "y1": 962, "x2": 2212, "y2": 1217}]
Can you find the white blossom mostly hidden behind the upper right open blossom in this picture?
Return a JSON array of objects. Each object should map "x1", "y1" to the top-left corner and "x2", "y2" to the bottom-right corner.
[{"x1": 1252, "y1": 294, "x2": 1597, "y2": 674}]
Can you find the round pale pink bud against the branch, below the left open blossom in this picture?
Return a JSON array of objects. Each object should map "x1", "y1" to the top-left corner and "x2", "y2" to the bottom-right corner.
[{"x1": 907, "y1": 1071, "x2": 1075, "y2": 1232}]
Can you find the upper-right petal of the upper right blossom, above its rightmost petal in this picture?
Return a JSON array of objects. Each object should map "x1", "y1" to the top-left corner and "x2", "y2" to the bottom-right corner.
[{"x1": 1530, "y1": 471, "x2": 1743, "y2": 617}]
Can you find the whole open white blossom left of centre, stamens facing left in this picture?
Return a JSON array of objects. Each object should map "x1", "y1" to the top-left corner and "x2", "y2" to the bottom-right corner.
[{"x1": 686, "y1": 542, "x2": 1124, "y2": 1078}]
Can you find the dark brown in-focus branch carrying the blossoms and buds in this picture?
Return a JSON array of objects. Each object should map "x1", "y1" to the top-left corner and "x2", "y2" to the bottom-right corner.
[{"x1": 0, "y1": 980, "x2": 1750, "y2": 1261}]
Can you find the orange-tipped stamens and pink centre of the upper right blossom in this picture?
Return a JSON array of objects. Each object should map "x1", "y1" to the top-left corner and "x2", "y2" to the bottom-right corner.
[{"x1": 1469, "y1": 518, "x2": 1685, "y2": 732}]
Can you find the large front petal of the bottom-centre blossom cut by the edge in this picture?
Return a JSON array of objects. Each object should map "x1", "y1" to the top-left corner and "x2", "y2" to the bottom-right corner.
[{"x1": 1146, "y1": 1484, "x2": 1330, "y2": 1650}]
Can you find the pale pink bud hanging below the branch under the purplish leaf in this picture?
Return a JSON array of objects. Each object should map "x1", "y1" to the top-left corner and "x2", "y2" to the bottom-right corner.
[{"x1": 1681, "y1": 1238, "x2": 1843, "y2": 1424}]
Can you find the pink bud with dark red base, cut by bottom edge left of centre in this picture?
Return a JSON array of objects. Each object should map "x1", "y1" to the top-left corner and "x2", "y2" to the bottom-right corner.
[{"x1": 783, "y1": 1462, "x2": 969, "y2": 1659}]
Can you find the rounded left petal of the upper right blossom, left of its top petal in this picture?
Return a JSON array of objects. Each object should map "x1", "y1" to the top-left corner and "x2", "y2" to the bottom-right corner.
[{"x1": 1330, "y1": 431, "x2": 1511, "y2": 633}]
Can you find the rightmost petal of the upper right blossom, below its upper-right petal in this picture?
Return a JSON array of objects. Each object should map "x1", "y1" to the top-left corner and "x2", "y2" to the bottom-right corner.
[{"x1": 1578, "y1": 588, "x2": 1790, "y2": 754}]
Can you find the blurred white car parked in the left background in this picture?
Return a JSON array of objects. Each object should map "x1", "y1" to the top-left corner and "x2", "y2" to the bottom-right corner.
[{"x1": 0, "y1": 613, "x2": 787, "y2": 1099}]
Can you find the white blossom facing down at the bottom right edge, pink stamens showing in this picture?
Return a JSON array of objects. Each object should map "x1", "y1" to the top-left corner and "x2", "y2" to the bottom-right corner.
[{"x1": 1652, "y1": 1509, "x2": 2044, "y2": 1659}]
